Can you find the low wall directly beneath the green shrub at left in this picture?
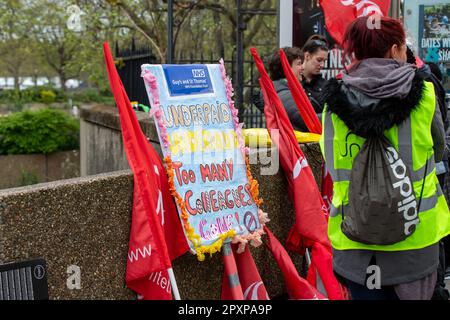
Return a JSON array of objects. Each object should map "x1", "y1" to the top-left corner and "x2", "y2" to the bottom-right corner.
[{"x1": 0, "y1": 150, "x2": 80, "y2": 189}]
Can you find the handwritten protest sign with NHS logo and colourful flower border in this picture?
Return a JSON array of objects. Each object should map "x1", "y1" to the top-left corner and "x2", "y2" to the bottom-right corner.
[{"x1": 142, "y1": 62, "x2": 267, "y2": 260}]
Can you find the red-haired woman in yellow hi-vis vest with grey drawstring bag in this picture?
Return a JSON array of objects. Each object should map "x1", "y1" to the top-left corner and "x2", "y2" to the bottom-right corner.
[{"x1": 320, "y1": 16, "x2": 450, "y2": 300}]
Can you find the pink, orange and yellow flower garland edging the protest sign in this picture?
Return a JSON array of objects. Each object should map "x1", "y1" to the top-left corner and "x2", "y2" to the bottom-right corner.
[{"x1": 141, "y1": 59, "x2": 270, "y2": 261}]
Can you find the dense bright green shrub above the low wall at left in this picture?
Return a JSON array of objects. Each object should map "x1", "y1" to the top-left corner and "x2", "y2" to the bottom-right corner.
[{"x1": 0, "y1": 109, "x2": 80, "y2": 155}]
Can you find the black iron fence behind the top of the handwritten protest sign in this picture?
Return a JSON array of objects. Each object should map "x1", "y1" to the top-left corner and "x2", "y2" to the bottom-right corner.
[{"x1": 116, "y1": 44, "x2": 266, "y2": 128}]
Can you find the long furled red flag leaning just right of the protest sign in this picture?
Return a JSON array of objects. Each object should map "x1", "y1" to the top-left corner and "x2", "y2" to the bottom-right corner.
[{"x1": 250, "y1": 48, "x2": 330, "y2": 250}]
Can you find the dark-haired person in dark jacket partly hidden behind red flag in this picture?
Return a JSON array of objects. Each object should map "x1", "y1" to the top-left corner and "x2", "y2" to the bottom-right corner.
[{"x1": 253, "y1": 47, "x2": 308, "y2": 132}]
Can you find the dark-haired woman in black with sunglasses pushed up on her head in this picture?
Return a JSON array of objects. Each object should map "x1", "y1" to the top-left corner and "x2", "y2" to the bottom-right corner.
[{"x1": 301, "y1": 34, "x2": 329, "y2": 113}]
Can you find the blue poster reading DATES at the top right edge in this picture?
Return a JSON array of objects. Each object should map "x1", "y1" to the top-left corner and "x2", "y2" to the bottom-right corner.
[{"x1": 418, "y1": 4, "x2": 450, "y2": 92}]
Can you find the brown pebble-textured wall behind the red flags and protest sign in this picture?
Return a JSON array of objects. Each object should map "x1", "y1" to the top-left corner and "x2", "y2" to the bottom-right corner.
[{"x1": 0, "y1": 143, "x2": 324, "y2": 299}]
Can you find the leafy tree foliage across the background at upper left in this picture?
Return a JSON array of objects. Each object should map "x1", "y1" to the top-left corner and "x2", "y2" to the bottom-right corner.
[{"x1": 0, "y1": 0, "x2": 277, "y2": 91}]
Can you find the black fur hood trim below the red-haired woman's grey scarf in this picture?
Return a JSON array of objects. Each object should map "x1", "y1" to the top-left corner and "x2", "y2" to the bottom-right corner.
[{"x1": 325, "y1": 71, "x2": 424, "y2": 138}]
